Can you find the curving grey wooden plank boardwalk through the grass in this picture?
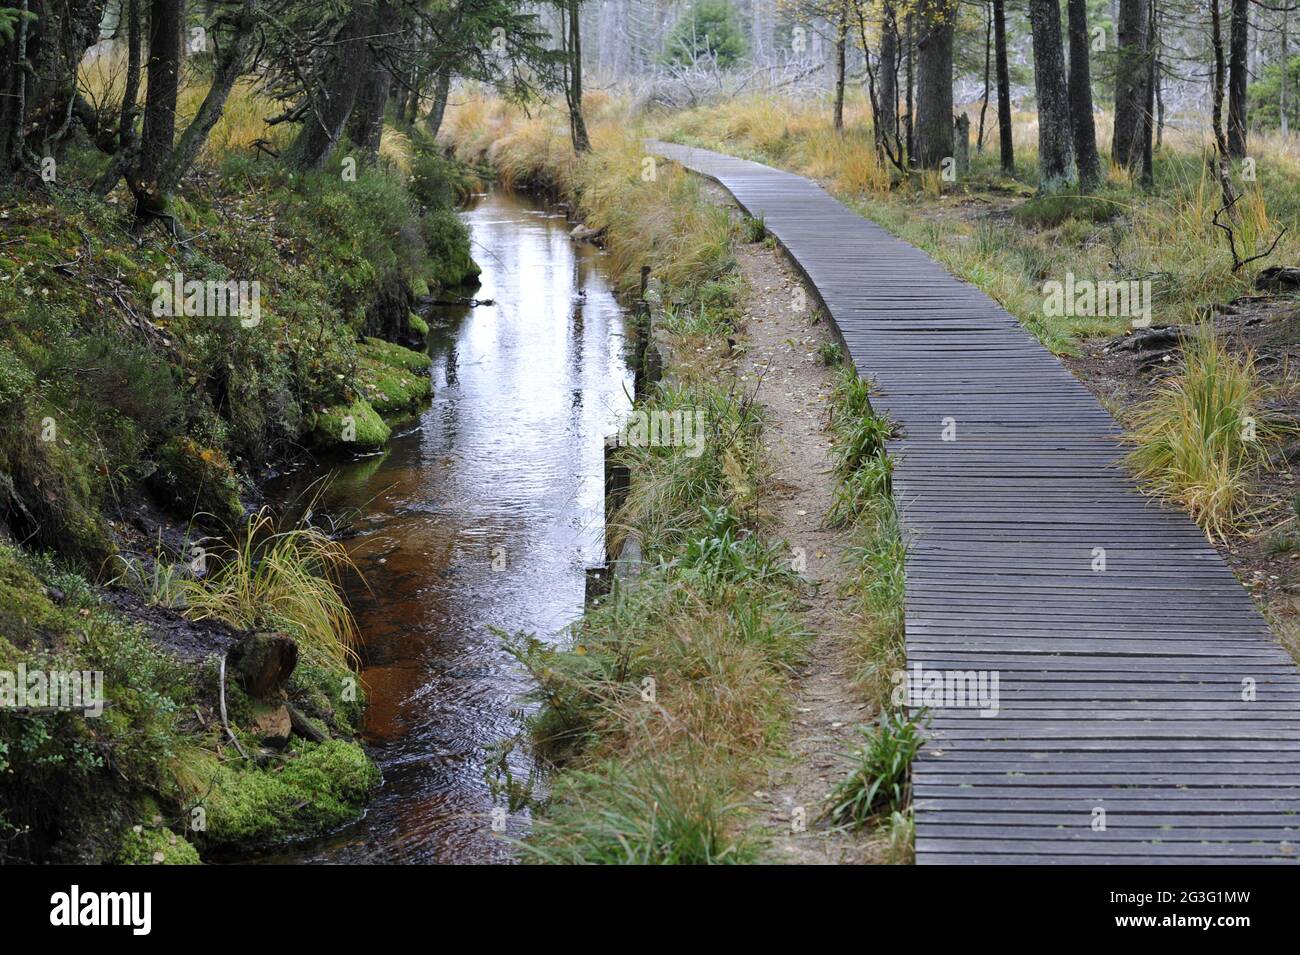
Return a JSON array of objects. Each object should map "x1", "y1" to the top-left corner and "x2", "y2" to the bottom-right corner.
[{"x1": 647, "y1": 142, "x2": 1300, "y2": 864}]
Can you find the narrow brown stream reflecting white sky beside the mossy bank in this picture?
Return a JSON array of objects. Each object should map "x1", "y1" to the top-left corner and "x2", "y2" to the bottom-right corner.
[{"x1": 263, "y1": 194, "x2": 632, "y2": 863}]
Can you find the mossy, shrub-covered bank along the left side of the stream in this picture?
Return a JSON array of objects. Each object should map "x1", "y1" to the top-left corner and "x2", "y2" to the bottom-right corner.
[{"x1": 0, "y1": 115, "x2": 477, "y2": 863}]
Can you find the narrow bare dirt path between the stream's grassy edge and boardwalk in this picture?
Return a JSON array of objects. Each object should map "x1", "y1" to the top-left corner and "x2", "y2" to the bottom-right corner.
[{"x1": 718, "y1": 201, "x2": 874, "y2": 864}]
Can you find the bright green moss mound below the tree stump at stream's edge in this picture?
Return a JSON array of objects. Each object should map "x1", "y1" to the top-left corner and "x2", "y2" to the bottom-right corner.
[{"x1": 199, "y1": 739, "x2": 380, "y2": 846}]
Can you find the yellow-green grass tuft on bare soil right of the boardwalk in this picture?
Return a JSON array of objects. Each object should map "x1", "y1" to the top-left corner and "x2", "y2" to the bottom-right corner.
[{"x1": 1127, "y1": 329, "x2": 1279, "y2": 541}]
